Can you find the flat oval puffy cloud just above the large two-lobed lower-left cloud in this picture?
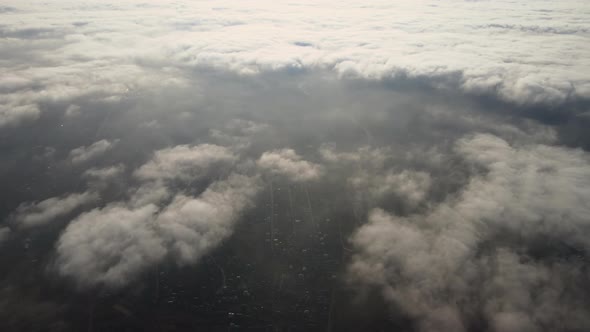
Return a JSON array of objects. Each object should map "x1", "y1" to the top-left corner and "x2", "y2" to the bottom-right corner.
[{"x1": 134, "y1": 144, "x2": 237, "y2": 181}]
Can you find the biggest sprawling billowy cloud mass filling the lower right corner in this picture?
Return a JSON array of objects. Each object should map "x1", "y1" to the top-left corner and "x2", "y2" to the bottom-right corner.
[{"x1": 349, "y1": 135, "x2": 590, "y2": 331}]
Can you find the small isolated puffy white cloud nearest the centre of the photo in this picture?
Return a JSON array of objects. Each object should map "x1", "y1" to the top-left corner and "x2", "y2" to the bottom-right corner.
[{"x1": 257, "y1": 149, "x2": 322, "y2": 181}]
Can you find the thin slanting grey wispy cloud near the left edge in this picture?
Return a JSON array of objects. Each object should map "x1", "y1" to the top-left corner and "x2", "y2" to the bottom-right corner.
[{"x1": 11, "y1": 192, "x2": 99, "y2": 228}]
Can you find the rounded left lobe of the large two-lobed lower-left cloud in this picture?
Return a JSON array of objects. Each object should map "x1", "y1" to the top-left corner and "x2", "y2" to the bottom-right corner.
[{"x1": 56, "y1": 204, "x2": 166, "y2": 287}]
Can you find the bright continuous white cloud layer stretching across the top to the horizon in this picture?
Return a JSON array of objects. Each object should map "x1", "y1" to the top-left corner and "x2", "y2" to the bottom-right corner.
[{"x1": 0, "y1": 0, "x2": 590, "y2": 134}]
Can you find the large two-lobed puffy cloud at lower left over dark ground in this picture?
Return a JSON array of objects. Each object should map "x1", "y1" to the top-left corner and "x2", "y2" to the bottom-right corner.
[{"x1": 56, "y1": 175, "x2": 259, "y2": 288}]
